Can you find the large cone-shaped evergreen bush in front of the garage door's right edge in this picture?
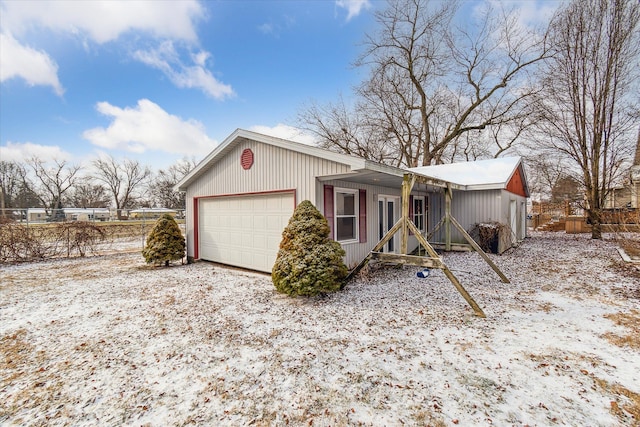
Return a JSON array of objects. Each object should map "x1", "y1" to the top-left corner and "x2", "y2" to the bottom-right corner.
[{"x1": 271, "y1": 200, "x2": 348, "y2": 296}]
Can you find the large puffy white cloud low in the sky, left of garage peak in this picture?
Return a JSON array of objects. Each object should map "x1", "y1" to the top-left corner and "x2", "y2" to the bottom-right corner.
[{"x1": 82, "y1": 99, "x2": 217, "y2": 156}]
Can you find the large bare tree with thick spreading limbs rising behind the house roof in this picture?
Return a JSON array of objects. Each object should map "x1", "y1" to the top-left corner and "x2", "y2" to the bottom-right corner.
[{"x1": 300, "y1": 0, "x2": 547, "y2": 166}]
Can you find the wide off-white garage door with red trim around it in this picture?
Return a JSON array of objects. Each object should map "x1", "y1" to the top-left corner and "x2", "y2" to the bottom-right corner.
[{"x1": 198, "y1": 193, "x2": 295, "y2": 272}]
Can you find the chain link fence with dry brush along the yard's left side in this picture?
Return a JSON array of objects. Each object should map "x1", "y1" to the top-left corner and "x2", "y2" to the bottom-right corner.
[{"x1": 0, "y1": 208, "x2": 185, "y2": 263}]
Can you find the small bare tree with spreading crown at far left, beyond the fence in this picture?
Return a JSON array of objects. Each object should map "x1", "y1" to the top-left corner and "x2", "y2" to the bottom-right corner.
[{"x1": 25, "y1": 157, "x2": 80, "y2": 216}]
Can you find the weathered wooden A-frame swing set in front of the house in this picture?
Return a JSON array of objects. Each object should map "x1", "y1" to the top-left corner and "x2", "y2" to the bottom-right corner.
[{"x1": 343, "y1": 173, "x2": 510, "y2": 317}]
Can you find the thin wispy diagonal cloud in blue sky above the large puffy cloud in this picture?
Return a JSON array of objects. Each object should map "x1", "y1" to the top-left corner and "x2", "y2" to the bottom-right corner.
[{"x1": 133, "y1": 41, "x2": 235, "y2": 100}]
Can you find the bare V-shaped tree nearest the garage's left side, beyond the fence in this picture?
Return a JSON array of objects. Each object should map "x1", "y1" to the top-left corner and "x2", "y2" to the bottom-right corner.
[{"x1": 93, "y1": 156, "x2": 151, "y2": 218}]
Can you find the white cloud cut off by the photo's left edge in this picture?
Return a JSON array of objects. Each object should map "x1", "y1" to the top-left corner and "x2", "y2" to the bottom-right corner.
[{"x1": 0, "y1": 33, "x2": 64, "y2": 95}]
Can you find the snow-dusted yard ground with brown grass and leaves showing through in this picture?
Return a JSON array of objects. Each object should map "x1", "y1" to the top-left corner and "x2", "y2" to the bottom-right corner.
[{"x1": 0, "y1": 233, "x2": 640, "y2": 426}]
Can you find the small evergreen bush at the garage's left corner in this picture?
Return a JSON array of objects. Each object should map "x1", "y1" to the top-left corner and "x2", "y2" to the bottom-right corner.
[{"x1": 142, "y1": 214, "x2": 186, "y2": 266}]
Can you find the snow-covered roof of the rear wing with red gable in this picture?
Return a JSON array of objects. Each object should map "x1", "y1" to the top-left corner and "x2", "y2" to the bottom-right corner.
[{"x1": 409, "y1": 157, "x2": 526, "y2": 190}]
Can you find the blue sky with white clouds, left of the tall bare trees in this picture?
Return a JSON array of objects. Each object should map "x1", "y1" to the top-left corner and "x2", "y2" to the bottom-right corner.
[{"x1": 0, "y1": 0, "x2": 558, "y2": 169}]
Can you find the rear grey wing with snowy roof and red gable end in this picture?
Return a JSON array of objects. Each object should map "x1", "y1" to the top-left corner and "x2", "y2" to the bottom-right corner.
[{"x1": 409, "y1": 157, "x2": 529, "y2": 253}]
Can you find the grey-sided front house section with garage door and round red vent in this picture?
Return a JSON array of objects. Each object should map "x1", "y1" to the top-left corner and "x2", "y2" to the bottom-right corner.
[{"x1": 175, "y1": 129, "x2": 528, "y2": 272}]
